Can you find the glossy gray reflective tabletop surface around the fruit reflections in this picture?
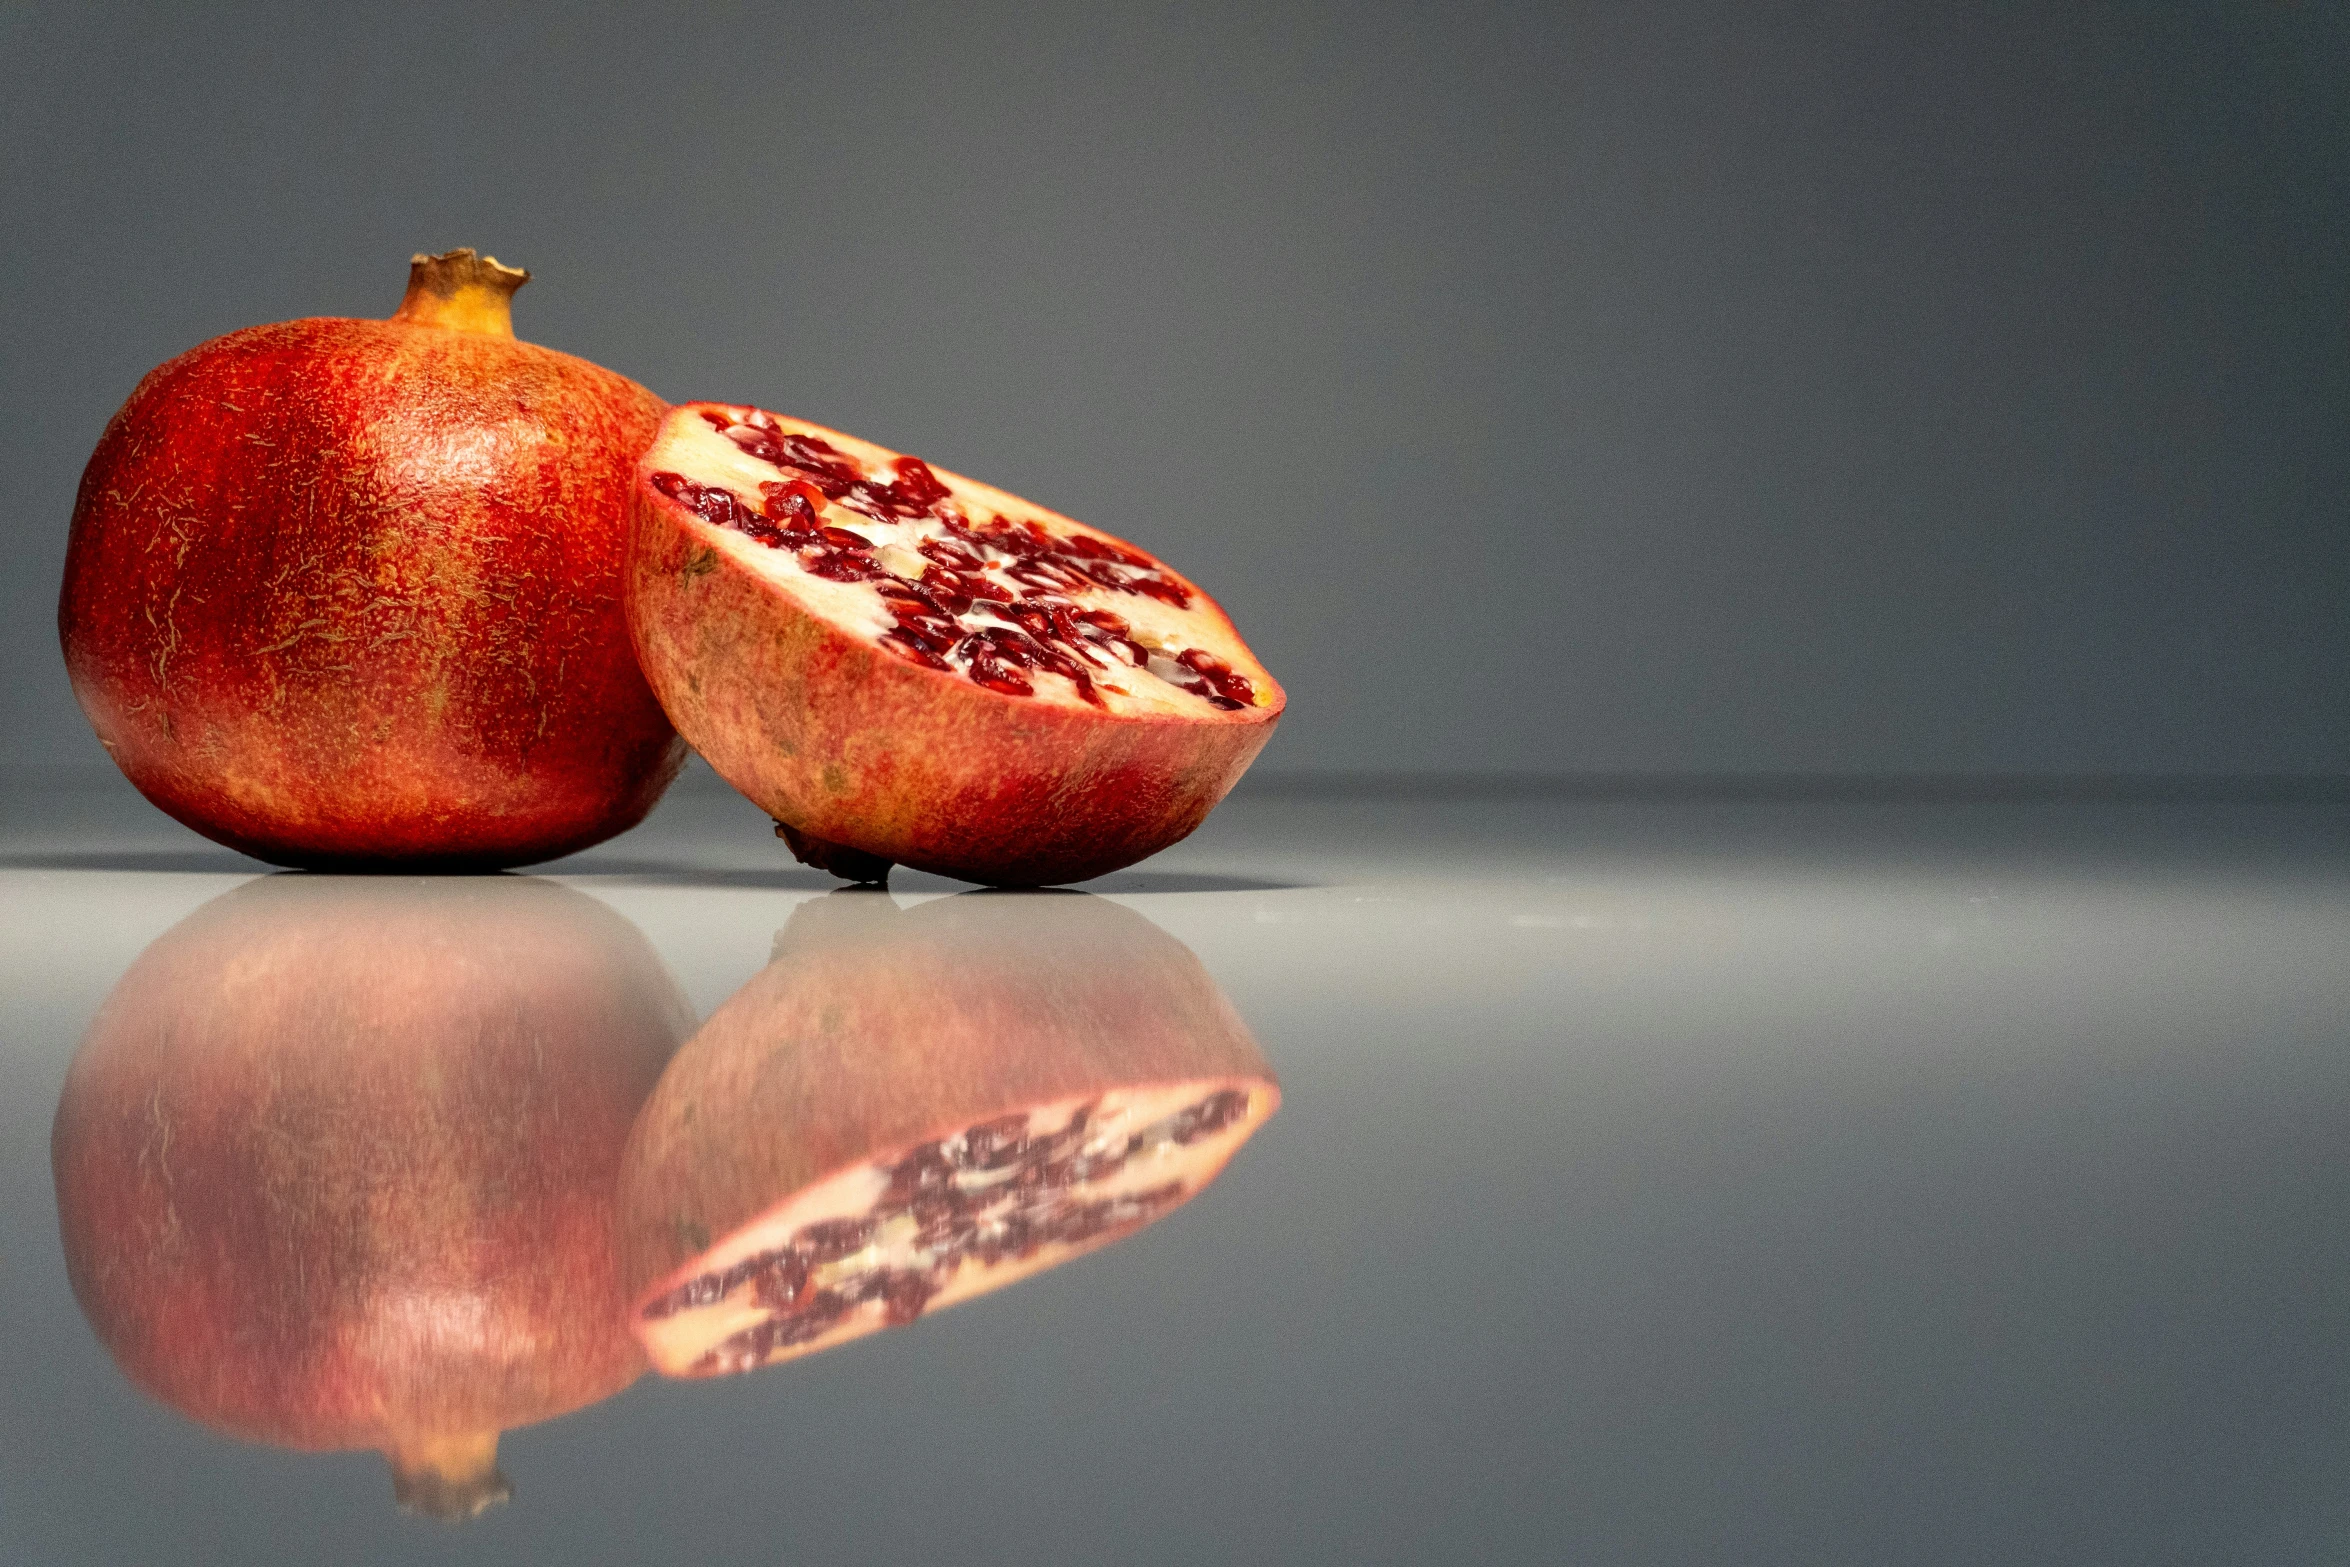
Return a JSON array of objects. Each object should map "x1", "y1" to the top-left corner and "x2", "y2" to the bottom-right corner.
[{"x1": 0, "y1": 780, "x2": 2350, "y2": 1565}]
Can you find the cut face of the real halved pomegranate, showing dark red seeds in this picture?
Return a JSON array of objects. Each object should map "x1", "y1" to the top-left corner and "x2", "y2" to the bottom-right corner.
[{"x1": 646, "y1": 404, "x2": 1271, "y2": 717}]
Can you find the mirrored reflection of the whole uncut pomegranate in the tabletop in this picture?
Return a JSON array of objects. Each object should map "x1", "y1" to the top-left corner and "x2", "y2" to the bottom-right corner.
[{"x1": 52, "y1": 879, "x2": 691, "y2": 1518}]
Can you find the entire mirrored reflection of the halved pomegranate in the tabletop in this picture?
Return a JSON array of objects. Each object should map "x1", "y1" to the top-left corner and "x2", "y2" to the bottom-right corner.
[{"x1": 620, "y1": 890, "x2": 1281, "y2": 1377}]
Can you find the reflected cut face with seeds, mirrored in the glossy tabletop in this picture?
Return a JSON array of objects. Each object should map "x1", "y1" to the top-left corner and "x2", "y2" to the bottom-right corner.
[{"x1": 637, "y1": 1078, "x2": 1271, "y2": 1377}]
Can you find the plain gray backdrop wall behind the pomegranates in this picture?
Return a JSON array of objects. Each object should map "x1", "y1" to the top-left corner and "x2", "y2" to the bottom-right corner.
[{"x1": 0, "y1": 0, "x2": 2350, "y2": 773}]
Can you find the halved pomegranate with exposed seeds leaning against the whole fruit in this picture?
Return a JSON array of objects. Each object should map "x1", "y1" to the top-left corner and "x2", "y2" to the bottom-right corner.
[{"x1": 627, "y1": 404, "x2": 1283, "y2": 886}]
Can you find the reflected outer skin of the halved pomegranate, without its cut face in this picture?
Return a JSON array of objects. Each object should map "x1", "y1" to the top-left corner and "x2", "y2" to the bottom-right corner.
[{"x1": 620, "y1": 890, "x2": 1281, "y2": 1374}]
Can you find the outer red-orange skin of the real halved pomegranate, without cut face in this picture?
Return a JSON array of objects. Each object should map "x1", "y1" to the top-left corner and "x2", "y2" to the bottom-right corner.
[{"x1": 627, "y1": 404, "x2": 1283, "y2": 886}]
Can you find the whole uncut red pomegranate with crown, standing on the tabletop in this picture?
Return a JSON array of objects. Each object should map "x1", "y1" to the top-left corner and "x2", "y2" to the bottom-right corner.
[{"x1": 59, "y1": 249, "x2": 684, "y2": 867}]
